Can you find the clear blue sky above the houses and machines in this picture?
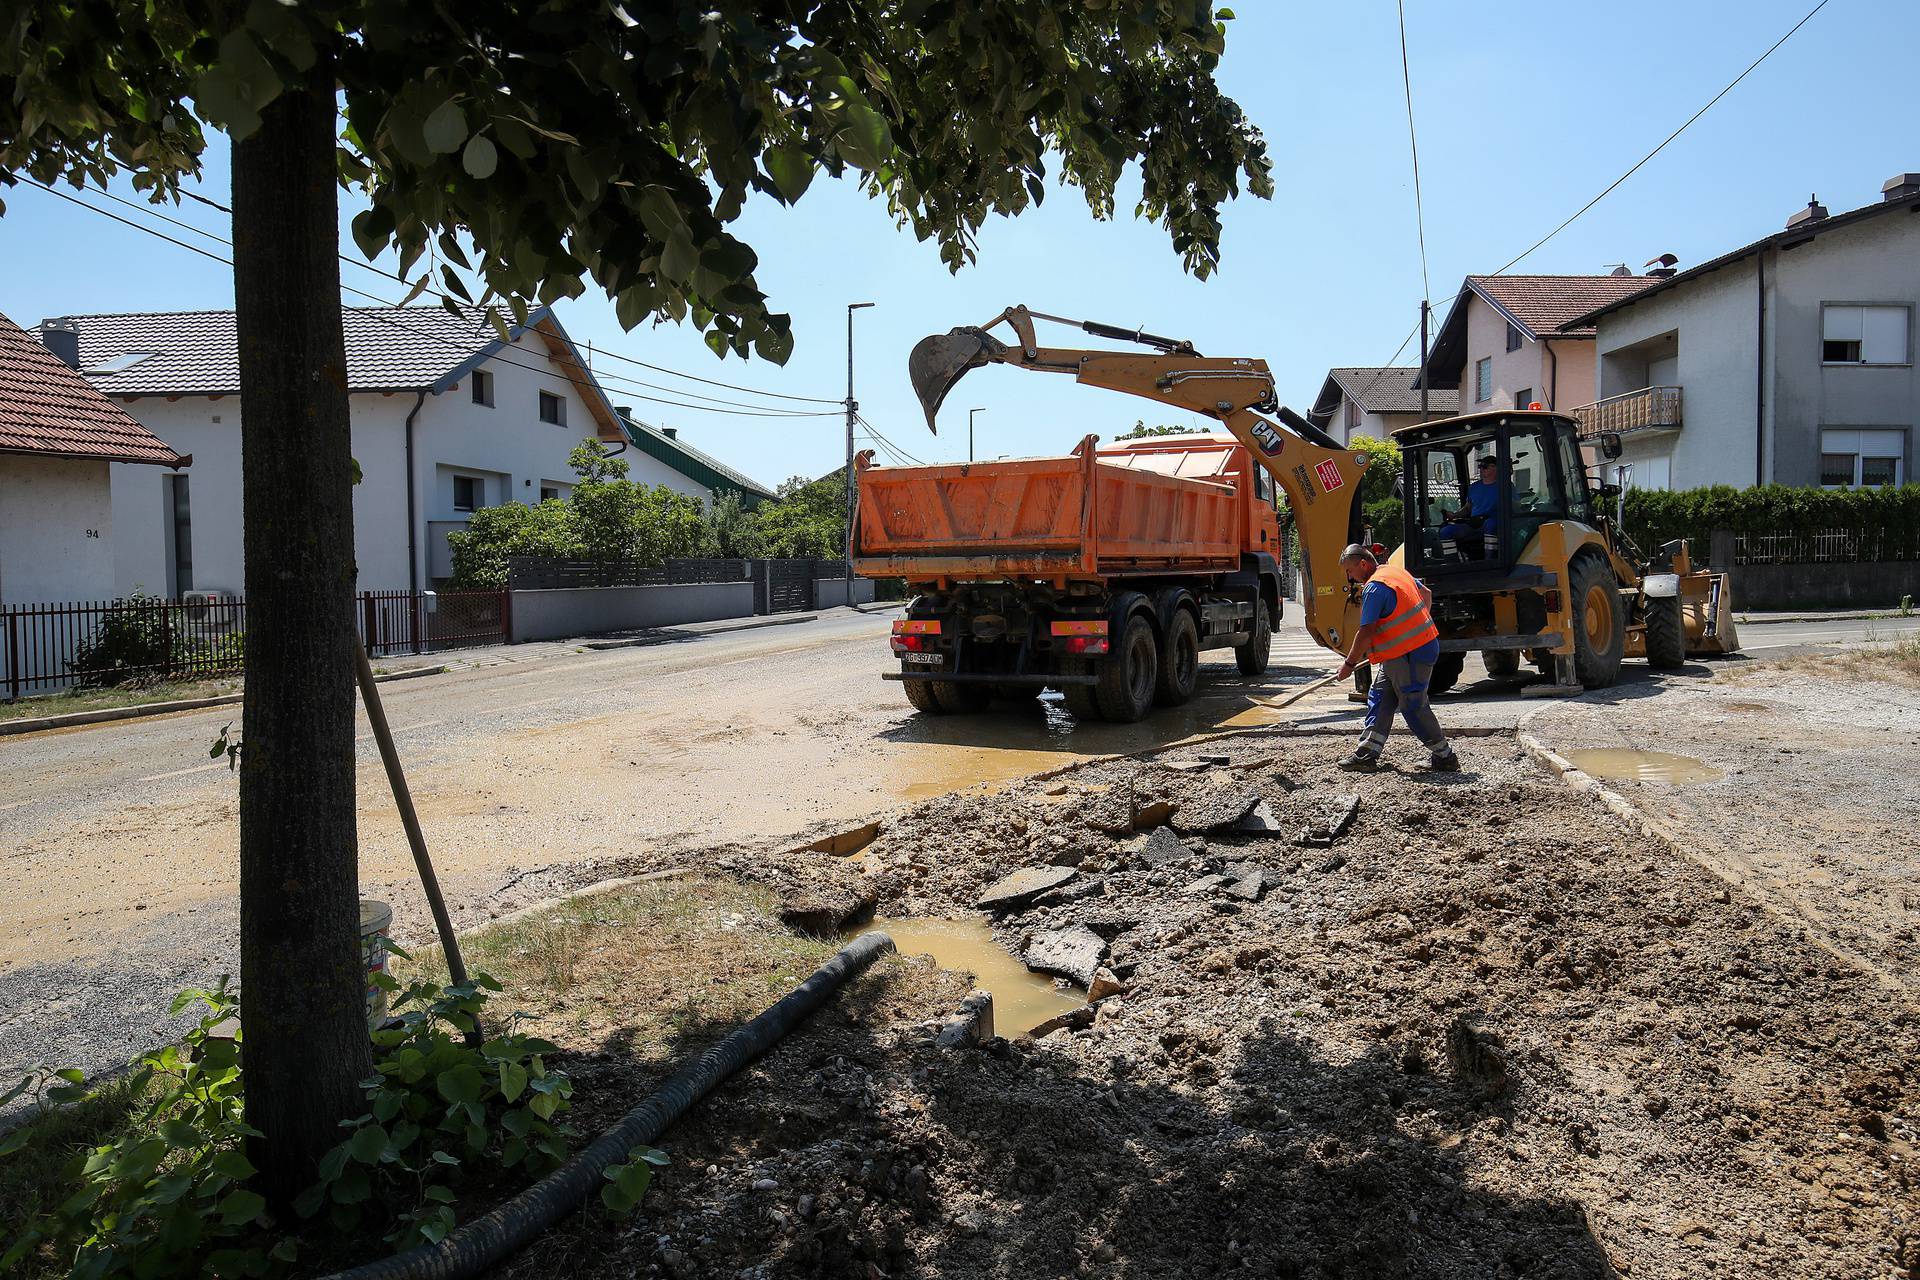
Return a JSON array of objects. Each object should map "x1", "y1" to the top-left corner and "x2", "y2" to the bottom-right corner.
[{"x1": 0, "y1": 0, "x2": 1920, "y2": 484}]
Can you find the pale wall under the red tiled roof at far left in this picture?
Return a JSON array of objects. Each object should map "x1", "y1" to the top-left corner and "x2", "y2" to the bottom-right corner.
[{"x1": 0, "y1": 453, "x2": 113, "y2": 604}]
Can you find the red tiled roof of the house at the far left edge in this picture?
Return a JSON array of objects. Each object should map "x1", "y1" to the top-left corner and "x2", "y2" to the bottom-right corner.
[{"x1": 0, "y1": 315, "x2": 186, "y2": 466}]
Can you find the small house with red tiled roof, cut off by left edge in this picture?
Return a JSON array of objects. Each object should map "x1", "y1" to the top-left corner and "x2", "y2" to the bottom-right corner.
[{"x1": 0, "y1": 315, "x2": 192, "y2": 610}]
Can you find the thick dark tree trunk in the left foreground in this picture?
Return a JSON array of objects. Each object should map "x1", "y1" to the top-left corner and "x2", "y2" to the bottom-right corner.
[{"x1": 232, "y1": 59, "x2": 372, "y2": 1203}]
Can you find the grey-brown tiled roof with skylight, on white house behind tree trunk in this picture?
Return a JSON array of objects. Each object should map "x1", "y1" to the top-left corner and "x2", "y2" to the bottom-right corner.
[{"x1": 61, "y1": 305, "x2": 499, "y2": 395}]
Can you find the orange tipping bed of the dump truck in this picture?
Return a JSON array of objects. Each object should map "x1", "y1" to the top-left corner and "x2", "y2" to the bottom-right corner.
[{"x1": 854, "y1": 438, "x2": 1246, "y2": 581}]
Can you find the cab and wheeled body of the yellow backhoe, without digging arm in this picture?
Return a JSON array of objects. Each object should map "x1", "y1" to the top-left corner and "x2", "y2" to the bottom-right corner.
[{"x1": 1394, "y1": 411, "x2": 1738, "y2": 693}]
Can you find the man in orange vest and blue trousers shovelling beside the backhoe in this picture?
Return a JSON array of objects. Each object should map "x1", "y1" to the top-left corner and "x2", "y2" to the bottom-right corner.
[{"x1": 1340, "y1": 543, "x2": 1459, "y2": 773}]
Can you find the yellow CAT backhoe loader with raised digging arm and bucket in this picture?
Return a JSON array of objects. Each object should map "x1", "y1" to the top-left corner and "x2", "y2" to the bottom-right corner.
[{"x1": 898, "y1": 307, "x2": 1738, "y2": 693}]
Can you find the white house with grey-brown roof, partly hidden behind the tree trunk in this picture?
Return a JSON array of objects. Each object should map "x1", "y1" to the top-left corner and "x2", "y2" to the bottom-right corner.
[{"x1": 42, "y1": 305, "x2": 764, "y2": 595}]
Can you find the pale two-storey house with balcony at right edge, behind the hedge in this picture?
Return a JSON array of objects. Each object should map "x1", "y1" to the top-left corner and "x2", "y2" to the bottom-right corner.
[{"x1": 1571, "y1": 173, "x2": 1920, "y2": 489}]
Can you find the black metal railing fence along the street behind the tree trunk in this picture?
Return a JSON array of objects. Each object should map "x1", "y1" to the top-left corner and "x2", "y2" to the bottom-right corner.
[{"x1": 0, "y1": 591, "x2": 509, "y2": 699}]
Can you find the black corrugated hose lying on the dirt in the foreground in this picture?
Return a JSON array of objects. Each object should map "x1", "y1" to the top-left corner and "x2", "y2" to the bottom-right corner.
[{"x1": 326, "y1": 933, "x2": 893, "y2": 1280}]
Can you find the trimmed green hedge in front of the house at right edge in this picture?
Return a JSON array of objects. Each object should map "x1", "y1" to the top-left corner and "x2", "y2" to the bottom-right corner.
[{"x1": 1626, "y1": 484, "x2": 1920, "y2": 558}]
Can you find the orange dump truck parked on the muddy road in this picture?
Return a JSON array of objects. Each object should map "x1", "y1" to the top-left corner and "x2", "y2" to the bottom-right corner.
[{"x1": 854, "y1": 434, "x2": 1281, "y2": 722}]
